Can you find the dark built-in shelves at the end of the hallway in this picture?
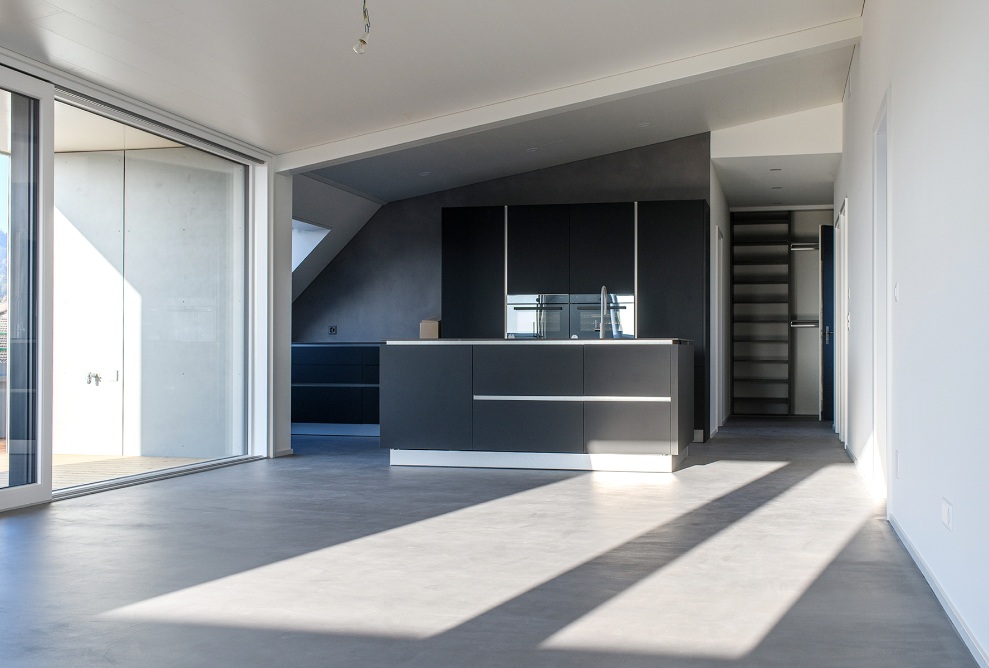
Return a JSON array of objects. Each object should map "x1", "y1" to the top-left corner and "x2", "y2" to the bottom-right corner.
[{"x1": 731, "y1": 212, "x2": 793, "y2": 415}]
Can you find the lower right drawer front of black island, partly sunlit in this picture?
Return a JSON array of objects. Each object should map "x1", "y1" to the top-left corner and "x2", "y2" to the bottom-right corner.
[{"x1": 584, "y1": 401, "x2": 673, "y2": 455}]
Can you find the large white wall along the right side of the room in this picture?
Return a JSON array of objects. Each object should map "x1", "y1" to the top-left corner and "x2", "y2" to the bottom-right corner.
[{"x1": 835, "y1": 0, "x2": 989, "y2": 665}]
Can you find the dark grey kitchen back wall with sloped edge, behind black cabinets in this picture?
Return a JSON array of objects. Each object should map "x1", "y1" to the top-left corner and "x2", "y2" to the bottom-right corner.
[{"x1": 292, "y1": 133, "x2": 711, "y2": 342}]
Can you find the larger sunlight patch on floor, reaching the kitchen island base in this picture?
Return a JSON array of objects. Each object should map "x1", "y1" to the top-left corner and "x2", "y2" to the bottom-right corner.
[{"x1": 103, "y1": 462, "x2": 784, "y2": 638}]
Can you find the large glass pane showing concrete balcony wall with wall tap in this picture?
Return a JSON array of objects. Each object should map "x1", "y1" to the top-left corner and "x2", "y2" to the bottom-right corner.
[{"x1": 52, "y1": 101, "x2": 247, "y2": 492}]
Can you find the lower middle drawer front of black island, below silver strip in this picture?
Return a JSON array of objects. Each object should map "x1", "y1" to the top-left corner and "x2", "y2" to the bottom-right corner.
[{"x1": 473, "y1": 401, "x2": 583, "y2": 452}]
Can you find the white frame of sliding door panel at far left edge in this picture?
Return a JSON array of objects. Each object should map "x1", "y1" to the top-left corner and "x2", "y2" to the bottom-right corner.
[{"x1": 0, "y1": 65, "x2": 55, "y2": 512}]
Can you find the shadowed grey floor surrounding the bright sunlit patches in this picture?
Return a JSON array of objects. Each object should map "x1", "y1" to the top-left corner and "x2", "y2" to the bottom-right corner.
[{"x1": 0, "y1": 420, "x2": 976, "y2": 668}]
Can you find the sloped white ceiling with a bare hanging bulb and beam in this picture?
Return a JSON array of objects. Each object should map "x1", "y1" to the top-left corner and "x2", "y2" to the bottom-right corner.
[{"x1": 0, "y1": 0, "x2": 863, "y2": 206}]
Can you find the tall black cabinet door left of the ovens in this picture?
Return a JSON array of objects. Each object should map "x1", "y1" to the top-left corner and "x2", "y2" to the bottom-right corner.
[{"x1": 441, "y1": 206, "x2": 505, "y2": 339}]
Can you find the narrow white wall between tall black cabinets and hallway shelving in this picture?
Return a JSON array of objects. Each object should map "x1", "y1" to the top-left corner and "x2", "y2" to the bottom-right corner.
[{"x1": 710, "y1": 163, "x2": 731, "y2": 436}]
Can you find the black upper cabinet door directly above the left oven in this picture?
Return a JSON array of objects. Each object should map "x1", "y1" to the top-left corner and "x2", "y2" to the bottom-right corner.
[{"x1": 508, "y1": 205, "x2": 568, "y2": 295}]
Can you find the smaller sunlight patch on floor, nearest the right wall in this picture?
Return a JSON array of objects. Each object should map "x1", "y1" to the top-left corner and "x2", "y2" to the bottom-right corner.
[{"x1": 542, "y1": 465, "x2": 875, "y2": 659}]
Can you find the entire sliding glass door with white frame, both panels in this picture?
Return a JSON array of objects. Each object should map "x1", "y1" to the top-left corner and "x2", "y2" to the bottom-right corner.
[{"x1": 0, "y1": 66, "x2": 251, "y2": 511}]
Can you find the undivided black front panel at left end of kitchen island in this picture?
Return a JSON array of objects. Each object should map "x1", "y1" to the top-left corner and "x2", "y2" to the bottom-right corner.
[{"x1": 381, "y1": 345, "x2": 473, "y2": 450}]
